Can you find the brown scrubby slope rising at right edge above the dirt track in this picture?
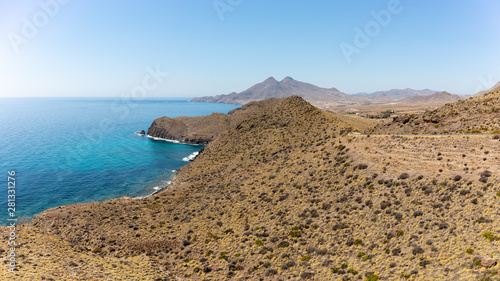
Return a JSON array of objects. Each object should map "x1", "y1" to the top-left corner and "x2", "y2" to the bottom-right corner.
[{"x1": 370, "y1": 87, "x2": 500, "y2": 134}]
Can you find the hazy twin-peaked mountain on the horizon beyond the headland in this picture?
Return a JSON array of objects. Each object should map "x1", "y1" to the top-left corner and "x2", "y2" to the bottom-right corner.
[{"x1": 191, "y1": 77, "x2": 366, "y2": 106}]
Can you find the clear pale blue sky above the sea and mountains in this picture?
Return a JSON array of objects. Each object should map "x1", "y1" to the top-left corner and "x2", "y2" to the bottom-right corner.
[{"x1": 0, "y1": 0, "x2": 500, "y2": 97}]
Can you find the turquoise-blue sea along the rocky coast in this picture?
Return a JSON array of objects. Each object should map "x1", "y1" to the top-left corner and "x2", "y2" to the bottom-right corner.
[{"x1": 0, "y1": 98, "x2": 239, "y2": 225}]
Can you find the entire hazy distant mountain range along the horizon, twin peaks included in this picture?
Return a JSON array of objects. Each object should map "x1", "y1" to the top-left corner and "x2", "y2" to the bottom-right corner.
[{"x1": 191, "y1": 77, "x2": 460, "y2": 108}]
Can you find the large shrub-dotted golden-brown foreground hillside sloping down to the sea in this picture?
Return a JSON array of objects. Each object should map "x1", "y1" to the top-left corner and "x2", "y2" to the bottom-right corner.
[{"x1": 0, "y1": 96, "x2": 500, "y2": 280}]
